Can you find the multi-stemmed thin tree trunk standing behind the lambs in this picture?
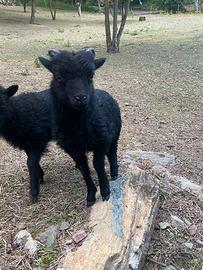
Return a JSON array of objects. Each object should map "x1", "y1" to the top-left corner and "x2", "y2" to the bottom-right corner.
[{"x1": 104, "y1": 0, "x2": 130, "y2": 53}]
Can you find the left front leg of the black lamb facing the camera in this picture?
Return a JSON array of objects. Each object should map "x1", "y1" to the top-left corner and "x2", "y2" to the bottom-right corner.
[{"x1": 72, "y1": 155, "x2": 97, "y2": 207}]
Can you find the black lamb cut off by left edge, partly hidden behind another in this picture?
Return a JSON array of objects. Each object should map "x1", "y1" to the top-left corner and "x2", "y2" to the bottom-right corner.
[{"x1": 0, "y1": 85, "x2": 51, "y2": 202}]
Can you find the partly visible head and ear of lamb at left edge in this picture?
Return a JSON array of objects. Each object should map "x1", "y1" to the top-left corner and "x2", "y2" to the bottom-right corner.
[{"x1": 0, "y1": 85, "x2": 18, "y2": 127}]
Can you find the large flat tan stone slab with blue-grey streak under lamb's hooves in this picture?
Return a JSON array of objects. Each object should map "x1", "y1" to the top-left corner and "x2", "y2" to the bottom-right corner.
[{"x1": 58, "y1": 164, "x2": 159, "y2": 270}]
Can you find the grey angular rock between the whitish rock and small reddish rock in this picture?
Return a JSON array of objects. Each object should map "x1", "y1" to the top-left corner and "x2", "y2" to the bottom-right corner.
[{"x1": 36, "y1": 225, "x2": 59, "y2": 248}]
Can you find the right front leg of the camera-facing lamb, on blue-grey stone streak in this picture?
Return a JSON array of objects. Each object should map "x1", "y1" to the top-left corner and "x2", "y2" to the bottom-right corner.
[{"x1": 93, "y1": 151, "x2": 110, "y2": 201}]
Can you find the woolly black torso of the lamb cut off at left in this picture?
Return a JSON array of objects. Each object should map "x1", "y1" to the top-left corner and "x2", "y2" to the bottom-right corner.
[{"x1": 2, "y1": 90, "x2": 51, "y2": 150}]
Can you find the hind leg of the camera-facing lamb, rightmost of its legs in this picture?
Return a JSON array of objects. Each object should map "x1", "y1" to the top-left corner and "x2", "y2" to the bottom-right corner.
[{"x1": 107, "y1": 141, "x2": 118, "y2": 181}]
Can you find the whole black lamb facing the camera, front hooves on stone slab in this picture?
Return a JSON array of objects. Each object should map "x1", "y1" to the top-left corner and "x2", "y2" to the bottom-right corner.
[{"x1": 39, "y1": 49, "x2": 121, "y2": 206}]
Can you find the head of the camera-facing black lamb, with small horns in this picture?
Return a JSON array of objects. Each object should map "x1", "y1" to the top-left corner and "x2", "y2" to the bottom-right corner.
[{"x1": 39, "y1": 49, "x2": 105, "y2": 111}]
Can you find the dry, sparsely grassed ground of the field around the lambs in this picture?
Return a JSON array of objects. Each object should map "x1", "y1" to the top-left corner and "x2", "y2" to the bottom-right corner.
[{"x1": 0, "y1": 7, "x2": 203, "y2": 270}]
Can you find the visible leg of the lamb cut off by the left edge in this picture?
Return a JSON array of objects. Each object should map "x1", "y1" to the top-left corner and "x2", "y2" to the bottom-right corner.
[{"x1": 27, "y1": 151, "x2": 43, "y2": 203}]
